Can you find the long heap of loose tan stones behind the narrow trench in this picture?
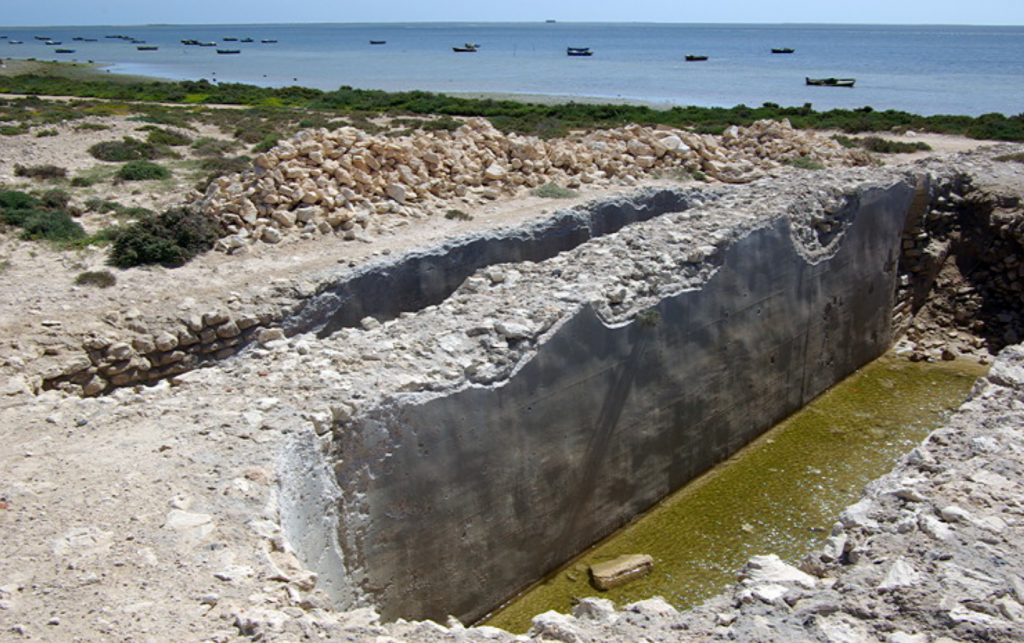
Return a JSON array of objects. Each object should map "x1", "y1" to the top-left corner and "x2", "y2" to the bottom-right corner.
[{"x1": 200, "y1": 119, "x2": 871, "y2": 252}]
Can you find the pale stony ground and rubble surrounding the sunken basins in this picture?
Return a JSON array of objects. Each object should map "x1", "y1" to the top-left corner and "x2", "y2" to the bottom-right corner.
[{"x1": 0, "y1": 109, "x2": 1024, "y2": 643}]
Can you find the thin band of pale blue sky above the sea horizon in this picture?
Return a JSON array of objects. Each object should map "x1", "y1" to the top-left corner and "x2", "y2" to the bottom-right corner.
[{"x1": 0, "y1": 0, "x2": 1024, "y2": 27}]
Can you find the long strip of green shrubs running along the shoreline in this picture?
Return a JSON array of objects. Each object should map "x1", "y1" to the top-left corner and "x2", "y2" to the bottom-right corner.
[{"x1": 0, "y1": 63, "x2": 1024, "y2": 141}]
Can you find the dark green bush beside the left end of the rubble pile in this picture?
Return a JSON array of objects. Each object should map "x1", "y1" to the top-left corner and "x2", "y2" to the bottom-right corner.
[{"x1": 111, "y1": 208, "x2": 219, "y2": 268}]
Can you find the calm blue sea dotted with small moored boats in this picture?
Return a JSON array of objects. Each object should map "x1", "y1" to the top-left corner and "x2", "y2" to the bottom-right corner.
[{"x1": 0, "y1": 18, "x2": 1024, "y2": 116}]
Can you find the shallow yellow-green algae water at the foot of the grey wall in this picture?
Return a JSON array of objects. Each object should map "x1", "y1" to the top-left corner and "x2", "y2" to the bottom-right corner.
[{"x1": 482, "y1": 355, "x2": 986, "y2": 633}]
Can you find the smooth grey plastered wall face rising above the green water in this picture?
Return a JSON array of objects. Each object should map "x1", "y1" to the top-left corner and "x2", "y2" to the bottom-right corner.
[{"x1": 331, "y1": 181, "x2": 914, "y2": 620}]
